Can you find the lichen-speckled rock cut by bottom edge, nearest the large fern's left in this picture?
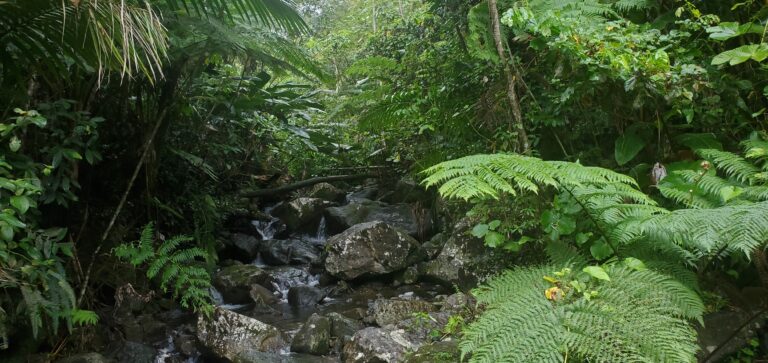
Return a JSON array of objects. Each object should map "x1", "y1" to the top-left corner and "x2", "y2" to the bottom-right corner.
[{"x1": 341, "y1": 328, "x2": 418, "y2": 363}]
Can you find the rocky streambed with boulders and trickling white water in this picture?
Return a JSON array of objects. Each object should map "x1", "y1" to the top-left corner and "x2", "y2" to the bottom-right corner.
[{"x1": 63, "y1": 181, "x2": 498, "y2": 363}]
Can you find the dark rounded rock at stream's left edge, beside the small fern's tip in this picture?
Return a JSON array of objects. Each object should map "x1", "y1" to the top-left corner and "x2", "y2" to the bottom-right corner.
[{"x1": 213, "y1": 265, "x2": 274, "y2": 304}]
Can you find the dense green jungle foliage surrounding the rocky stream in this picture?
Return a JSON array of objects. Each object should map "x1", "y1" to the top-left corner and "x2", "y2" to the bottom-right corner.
[{"x1": 0, "y1": 0, "x2": 768, "y2": 362}]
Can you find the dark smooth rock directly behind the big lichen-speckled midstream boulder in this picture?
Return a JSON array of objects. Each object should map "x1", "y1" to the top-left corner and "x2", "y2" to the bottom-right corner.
[{"x1": 325, "y1": 200, "x2": 432, "y2": 240}]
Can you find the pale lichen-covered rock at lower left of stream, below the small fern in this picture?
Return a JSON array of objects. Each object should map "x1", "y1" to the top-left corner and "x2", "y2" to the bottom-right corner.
[{"x1": 197, "y1": 308, "x2": 286, "y2": 360}]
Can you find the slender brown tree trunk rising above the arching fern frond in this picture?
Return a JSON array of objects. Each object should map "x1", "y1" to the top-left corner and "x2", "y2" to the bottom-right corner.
[{"x1": 488, "y1": 0, "x2": 529, "y2": 153}]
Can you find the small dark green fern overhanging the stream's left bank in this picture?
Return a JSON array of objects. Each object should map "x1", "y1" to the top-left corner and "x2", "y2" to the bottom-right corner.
[{"x1": 115, "y1": 223, "x2": 213, "y2": 313}]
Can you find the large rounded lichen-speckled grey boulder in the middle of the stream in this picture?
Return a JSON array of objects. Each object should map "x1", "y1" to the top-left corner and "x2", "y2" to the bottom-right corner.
[{"x1": 325, "y1": 221, "x2": 419, "y2": 280}]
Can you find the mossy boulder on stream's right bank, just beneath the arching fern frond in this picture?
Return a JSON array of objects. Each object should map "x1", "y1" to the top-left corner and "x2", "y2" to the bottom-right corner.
[{"x1": 419, "y1": 219, "x2": 503, "y2": 289}]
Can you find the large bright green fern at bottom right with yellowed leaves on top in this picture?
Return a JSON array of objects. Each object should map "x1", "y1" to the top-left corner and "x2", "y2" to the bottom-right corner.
[{"x1": 460, "y1": 265, "x2": 703, "y2": 362}]
